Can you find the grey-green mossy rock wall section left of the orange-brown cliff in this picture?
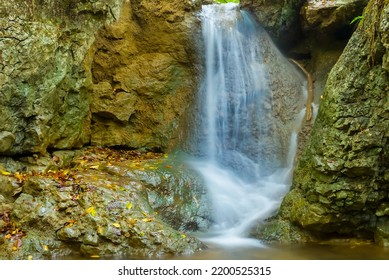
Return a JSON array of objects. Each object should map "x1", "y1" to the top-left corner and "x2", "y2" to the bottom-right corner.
[{"x1": 0, "y1": 0, "x2": 120, "y2": 155}]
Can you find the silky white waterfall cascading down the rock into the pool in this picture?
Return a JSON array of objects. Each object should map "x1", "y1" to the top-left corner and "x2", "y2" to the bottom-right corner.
[{"x1": 190, "y1": 3, "x2": 304, "y2": 245}]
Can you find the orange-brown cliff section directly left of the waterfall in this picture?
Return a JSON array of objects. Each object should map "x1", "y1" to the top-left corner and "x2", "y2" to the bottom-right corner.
[{"x1": 91, "y1": 1, "x2": 202, "y2": 149}]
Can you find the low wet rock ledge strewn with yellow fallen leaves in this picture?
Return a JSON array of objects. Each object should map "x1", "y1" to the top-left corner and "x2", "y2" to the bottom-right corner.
[{"x1": 0, "y1": 150, "x2": 209, "y2": 259}]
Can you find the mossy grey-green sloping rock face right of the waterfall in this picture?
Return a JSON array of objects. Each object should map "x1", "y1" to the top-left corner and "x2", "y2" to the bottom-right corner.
[{"x1": 258, "y1": 0, "x2": 389, "y2": 245}]
